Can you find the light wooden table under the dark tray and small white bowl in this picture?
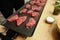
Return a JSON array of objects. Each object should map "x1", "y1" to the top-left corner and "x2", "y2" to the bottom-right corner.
[{"x1": 13, "y1": 0, "x2": 60, "y2": 40}]
